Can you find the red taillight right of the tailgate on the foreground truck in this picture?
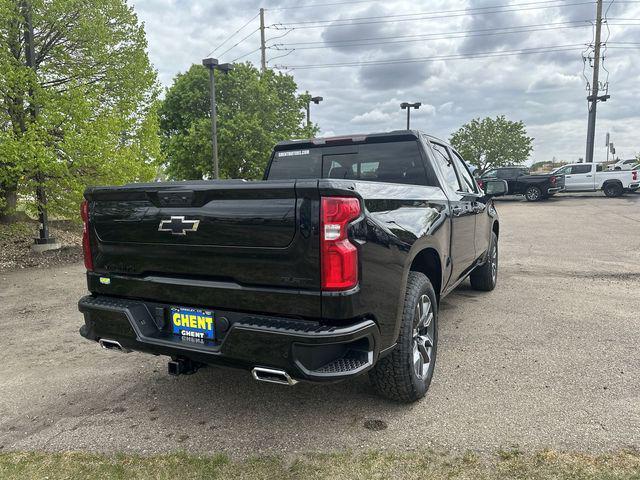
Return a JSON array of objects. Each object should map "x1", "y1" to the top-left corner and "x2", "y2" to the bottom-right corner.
[{"x1": 320, "y1": 197, "x2": 360, "y2": 290}]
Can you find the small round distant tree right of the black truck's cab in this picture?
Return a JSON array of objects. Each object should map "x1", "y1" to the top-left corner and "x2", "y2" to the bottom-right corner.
[{"x1": 450, "y1": 115, "x2": 533, "y2": 174}]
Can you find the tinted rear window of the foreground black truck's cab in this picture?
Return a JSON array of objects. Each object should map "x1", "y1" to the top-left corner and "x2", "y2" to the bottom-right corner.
[{"x1": 267, "y1": 141, "x2": 434, "y2": 185}]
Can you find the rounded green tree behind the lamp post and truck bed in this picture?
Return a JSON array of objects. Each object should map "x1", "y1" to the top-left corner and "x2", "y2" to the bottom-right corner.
[{"x1": 160, "y1": 63, "x2": 318, "y2": 179}]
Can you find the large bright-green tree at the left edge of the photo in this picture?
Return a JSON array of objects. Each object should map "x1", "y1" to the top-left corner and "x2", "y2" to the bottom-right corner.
[{"x1": 0, "y1": 0, "x2": 160, "y2": 221}]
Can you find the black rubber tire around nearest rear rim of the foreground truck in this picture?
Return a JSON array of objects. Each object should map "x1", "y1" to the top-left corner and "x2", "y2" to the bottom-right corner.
[{"x1": 369, "y1": 272, "x2": 438, "y2": 402}]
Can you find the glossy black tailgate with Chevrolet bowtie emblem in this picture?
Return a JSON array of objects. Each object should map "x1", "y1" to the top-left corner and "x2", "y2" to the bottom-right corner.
[{"x1": 85, "y1": 180, "x2": 320, "y2": 315}]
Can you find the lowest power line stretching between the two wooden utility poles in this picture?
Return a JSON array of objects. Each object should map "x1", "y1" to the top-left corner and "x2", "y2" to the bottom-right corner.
[{"x1": 276, "y1": 43, "x2": 584, "y2": 70}]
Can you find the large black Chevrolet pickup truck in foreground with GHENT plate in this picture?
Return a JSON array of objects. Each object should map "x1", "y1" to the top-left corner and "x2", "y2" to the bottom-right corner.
[{"x1": 79, "y1": 130, "x2": 506, "y2": 401}]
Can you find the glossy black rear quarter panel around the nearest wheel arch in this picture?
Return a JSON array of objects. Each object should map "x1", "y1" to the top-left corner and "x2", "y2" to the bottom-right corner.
[{"x1": 319, "y1": 180, "x2": 451, "y2": 349}]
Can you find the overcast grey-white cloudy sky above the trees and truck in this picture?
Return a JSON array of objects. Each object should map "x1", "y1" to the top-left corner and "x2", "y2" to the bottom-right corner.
[{"x1": 133, "y1": 0, "x2": 640, "y2": 162}]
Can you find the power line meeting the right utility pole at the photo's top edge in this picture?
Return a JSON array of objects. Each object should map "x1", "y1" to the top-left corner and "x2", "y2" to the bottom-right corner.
[{"x1": 270, "y1": 0, "x2": 594, "y2": 29}]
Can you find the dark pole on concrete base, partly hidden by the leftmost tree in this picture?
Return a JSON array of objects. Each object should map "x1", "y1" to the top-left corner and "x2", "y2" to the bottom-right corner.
[{"x1": 22, "y1": 0, "x2": 60, "y2": 251}]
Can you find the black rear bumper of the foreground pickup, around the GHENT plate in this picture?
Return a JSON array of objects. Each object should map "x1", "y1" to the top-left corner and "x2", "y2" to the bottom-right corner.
[{"x1": 78, "y1": 296, "x2": 380, "y2": 382}]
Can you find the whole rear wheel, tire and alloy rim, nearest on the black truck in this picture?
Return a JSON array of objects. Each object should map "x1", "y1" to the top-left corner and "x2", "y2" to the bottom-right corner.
[{"x1": 369, "y1": 272, "x2": 438, "y2": 402}]
